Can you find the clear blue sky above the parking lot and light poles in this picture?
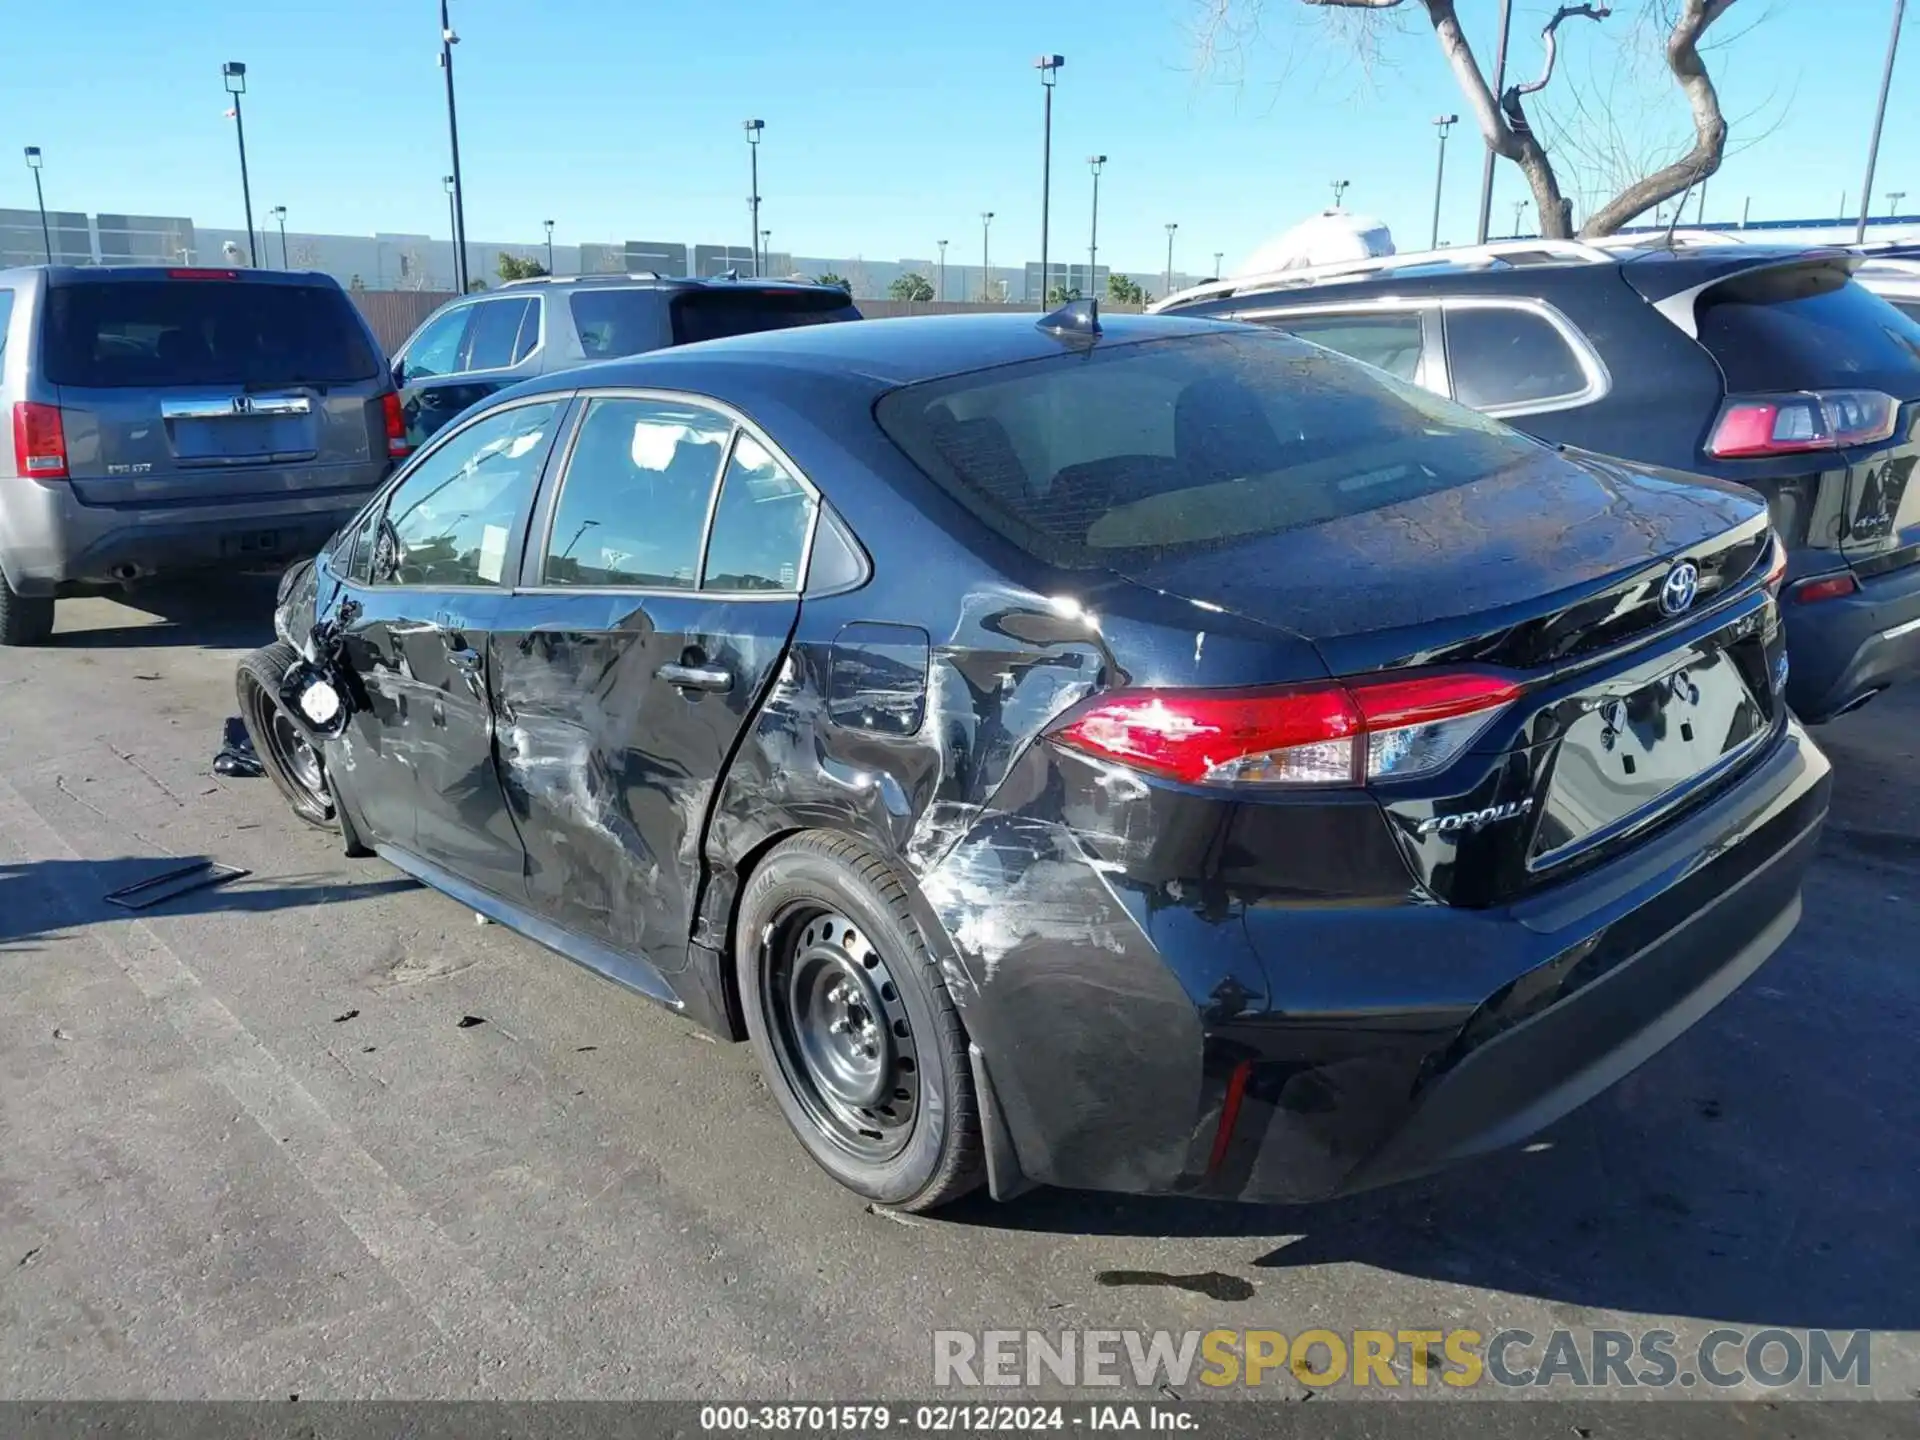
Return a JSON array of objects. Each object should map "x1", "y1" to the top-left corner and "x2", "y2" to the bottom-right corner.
[{"x1": 0, "y1": 0, "x2": 1920, "y2": 273}]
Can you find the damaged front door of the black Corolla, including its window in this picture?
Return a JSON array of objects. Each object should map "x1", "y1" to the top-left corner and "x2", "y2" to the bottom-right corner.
[{"x1": 336, "y1": 397, "x2": 566, "y2": 904}]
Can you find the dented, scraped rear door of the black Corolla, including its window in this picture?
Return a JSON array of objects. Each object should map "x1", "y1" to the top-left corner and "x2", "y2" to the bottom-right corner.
[{"x1": 493, "y1": 396, "x2": 814, "y2": 975}]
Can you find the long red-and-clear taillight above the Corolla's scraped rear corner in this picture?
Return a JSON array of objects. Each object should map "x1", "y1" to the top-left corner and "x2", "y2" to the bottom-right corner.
[{"x1": 1048, "y1": 670, "x2": 1521, "y2": 785}]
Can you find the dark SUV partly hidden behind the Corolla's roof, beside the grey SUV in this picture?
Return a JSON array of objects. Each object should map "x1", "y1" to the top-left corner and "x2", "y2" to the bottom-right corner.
[{"x1": 394, "y1": 275, "x2": 860, "y2": 444}]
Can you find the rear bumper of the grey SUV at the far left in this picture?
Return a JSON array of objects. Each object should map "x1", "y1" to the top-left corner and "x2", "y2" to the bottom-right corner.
[{"x1": 0, "y1": 476, "x2": 386, "y2": 595}]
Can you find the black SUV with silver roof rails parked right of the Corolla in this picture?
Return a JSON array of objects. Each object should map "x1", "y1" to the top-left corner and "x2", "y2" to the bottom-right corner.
[{"x1": 1160, "y1": 236, "x2": 1920, "y2": 722}]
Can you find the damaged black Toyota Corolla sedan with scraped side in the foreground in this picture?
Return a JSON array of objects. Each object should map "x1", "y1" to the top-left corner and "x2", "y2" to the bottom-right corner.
[{"x1": 240, "y1": 309, "x2": 1828, "y2": 1208}]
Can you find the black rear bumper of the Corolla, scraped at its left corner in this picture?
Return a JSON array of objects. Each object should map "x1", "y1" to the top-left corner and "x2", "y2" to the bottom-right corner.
[{"x1": 940, "y1": 724, "x2": 1830, "y2": 1202}]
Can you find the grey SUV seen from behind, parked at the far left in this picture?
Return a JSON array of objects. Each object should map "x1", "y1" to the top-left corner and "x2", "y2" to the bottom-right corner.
[{"x1": 0, "y1": 265, "x2": 407, "y2": 645}]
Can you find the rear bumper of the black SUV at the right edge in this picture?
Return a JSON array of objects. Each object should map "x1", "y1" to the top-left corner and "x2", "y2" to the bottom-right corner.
[{"x1": 1780, "y1": 564, "x2": 1920, "y2": 722}]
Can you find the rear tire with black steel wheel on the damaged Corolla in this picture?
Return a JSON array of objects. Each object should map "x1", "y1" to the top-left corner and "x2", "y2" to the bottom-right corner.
[{"x1": 733, "y1": 831, "x2": 985, "y2": 1210}]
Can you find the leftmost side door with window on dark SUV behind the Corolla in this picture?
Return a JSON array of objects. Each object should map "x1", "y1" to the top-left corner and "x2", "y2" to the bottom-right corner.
[{"x1": 394, "y1": 296, "x2": 543, "y2": 445}]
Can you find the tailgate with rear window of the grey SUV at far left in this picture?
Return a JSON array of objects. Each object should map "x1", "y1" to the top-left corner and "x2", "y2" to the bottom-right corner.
[{"x1": 40, "y1": 271, "x2": 388, "y2": 505}]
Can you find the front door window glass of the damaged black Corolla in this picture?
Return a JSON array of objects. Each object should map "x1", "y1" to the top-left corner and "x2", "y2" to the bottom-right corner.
[{"x1": 370, "y1": 399, "x2": 563, "y2": 586}]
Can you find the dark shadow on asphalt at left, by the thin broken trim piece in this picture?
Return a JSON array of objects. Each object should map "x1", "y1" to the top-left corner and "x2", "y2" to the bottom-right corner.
[{"x1": 0, "y1": 854, "x2": 419, "y2": 954}]
